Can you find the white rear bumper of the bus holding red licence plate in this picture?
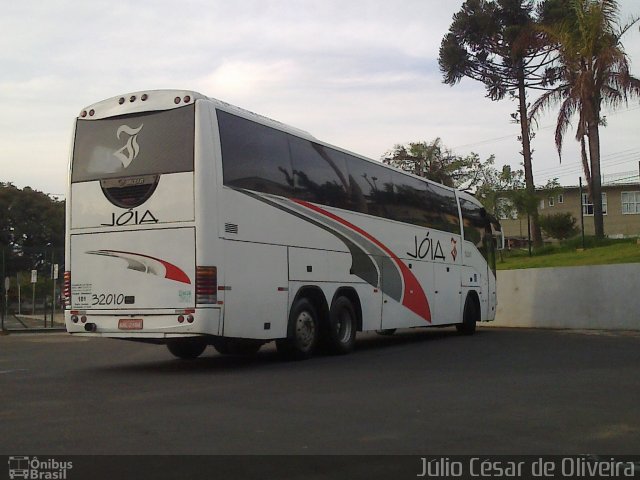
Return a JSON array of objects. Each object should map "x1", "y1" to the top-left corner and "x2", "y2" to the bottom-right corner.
[{"x1": 65, "y1": 308, "x2": 220, "y2": 339}]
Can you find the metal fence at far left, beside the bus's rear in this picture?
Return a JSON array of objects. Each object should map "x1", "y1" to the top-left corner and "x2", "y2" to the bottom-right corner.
[{"x1": 0, "y1": 247, "x2": 64, "y2": 331}]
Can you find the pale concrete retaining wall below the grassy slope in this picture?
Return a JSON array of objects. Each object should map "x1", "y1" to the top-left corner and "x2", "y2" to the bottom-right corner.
[{"x1": 490, "y1": 263, "x2": 640, "y2": 330}]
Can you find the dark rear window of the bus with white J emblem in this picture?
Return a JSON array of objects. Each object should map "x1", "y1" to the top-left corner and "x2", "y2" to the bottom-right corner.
[{"x1": 71, "y1": 105, "x2": 195, "y2": 182}]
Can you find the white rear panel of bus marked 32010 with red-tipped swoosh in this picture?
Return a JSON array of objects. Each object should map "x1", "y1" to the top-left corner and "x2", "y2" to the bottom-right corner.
[{"x1": 70, "y1": 227, "x2": 195, "y2": 311}]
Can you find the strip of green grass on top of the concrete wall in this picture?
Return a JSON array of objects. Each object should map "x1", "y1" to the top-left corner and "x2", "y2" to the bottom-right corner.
[{"x1": 497, "y1": 238, "x2": 640, "y2": 270}]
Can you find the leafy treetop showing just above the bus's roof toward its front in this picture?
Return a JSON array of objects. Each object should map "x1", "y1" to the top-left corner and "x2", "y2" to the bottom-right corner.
[{"x1": 382, "y1": 138, "x2": 493, "y2": 190}]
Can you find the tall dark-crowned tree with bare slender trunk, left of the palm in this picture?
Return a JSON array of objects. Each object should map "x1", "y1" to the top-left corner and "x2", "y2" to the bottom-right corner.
[{"x1": 438, "y1": 0, "x2": 553, "y2": 245}]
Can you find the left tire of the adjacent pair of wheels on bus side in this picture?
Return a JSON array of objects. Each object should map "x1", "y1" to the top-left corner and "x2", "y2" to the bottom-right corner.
[{"x1": 276, "y1": 297, "x2": 319, "y2": 360}]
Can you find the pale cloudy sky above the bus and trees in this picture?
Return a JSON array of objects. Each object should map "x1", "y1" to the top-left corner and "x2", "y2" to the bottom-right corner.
[{"x1": 0, "y1": 0, "x2": 640, "y2": 196}]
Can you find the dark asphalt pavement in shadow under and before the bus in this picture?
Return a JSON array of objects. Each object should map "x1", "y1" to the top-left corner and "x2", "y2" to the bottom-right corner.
[{"x1": 0, "y1": 328, "x2": 640, "y2": 455}]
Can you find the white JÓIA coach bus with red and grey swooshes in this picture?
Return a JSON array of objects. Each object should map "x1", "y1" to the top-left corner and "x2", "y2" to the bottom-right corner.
[{"x1": 65, "y1": 90, "x2": 499, "y2": 358}]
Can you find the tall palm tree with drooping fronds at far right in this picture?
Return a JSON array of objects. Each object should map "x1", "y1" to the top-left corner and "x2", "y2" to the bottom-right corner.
[{"x1": 530, "y1": 0, "x2": 640, "y2": 237}]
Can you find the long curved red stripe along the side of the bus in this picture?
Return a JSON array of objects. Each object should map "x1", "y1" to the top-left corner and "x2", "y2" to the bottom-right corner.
[{"x1": 292, "y1": 199, "x2": 431, "y2": 323}]
